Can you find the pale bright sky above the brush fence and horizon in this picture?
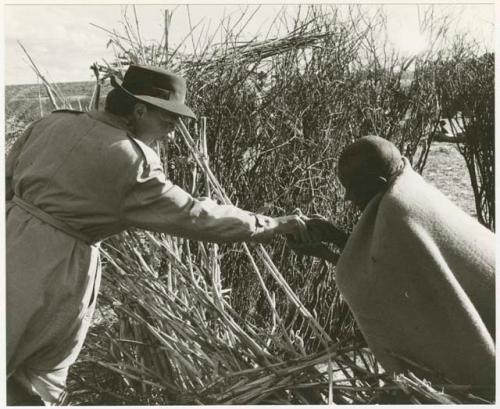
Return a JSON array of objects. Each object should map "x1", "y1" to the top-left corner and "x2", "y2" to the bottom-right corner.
[{"x1": 0, "y1": 3, "x2": 495, "y2": 85}]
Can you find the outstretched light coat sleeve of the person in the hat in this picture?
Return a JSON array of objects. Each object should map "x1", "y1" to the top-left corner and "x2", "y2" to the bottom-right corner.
[{"x1": 121, "y1": 140, "x2": 273, "y2": 243}]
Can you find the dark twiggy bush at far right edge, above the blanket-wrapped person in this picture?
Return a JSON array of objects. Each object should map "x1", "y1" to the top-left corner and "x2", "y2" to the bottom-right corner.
[{"x1": 435, "y1": 47, "x2": 495, "y2": 230}]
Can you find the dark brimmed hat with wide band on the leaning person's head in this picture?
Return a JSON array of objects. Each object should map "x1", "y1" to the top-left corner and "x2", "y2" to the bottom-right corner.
[{"x1": 110, "y1": 65, "x2": 196, "y2": 119}]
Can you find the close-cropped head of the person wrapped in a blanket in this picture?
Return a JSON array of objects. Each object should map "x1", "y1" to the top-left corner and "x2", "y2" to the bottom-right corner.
[{"x1": 338, "y1": 135, "x2": 403, "y2": 208}]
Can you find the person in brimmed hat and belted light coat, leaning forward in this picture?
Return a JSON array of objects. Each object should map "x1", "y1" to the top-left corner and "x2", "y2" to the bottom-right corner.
[{"x1": 6, "y1": 65, "x2": 306, "y2": 405}]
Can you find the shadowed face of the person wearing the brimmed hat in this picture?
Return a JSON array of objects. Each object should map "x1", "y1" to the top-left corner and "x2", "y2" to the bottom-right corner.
[{"x1": 132, "y1": 104, "x2": 178, "y2": 145}]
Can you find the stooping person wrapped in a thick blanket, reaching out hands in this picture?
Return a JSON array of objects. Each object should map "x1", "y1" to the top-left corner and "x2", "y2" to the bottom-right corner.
[{"x1": 288, "y1": 136, "x2": 495, "y2": 400}]
